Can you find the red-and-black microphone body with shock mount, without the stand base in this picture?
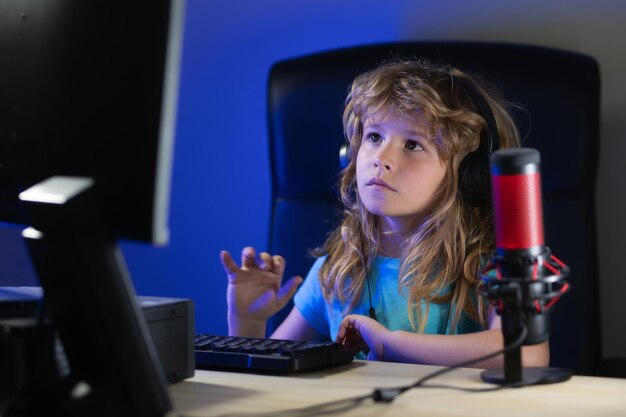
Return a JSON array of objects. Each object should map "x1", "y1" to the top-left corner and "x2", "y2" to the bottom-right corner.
[{"x1": 483, "y1": 148, "x2": 569, "y2": 345}]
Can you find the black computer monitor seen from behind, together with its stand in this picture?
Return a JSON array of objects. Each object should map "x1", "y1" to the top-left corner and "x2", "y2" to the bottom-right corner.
[{"x1": 0, "y1": 0, "x2": 184, "y2": 416}]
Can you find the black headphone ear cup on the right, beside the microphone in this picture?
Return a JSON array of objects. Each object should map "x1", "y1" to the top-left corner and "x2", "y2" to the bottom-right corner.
[{"x1": 459, "y1": 150, "x2": 491, "y2": 207}]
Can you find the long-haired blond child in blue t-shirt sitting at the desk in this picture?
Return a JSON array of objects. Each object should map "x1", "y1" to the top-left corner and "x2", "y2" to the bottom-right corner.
[{"x1": 220, "y1": 60, "x2": 549, "y2": 367}]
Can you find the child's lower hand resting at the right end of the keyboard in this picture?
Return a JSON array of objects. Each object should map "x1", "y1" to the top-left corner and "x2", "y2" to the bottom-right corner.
[{"x1": 335, "y1": 314, "x2": 389, "y2": 360}]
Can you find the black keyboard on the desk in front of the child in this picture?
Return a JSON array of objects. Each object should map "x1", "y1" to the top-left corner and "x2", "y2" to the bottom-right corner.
[{"x1": 195, "y1": 334, "x2": 354, "y2": 372}]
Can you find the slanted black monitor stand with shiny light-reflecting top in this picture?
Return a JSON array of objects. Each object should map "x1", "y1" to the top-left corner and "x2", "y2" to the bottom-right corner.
[{"x1": 10, "y1": 177, "x2": 172, "y2": 417}]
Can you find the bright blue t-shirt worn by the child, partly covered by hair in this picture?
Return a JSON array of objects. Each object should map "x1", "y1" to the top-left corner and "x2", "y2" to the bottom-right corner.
[{"x1": 294, "y1": 255, "x2": 483, "y2": 340}]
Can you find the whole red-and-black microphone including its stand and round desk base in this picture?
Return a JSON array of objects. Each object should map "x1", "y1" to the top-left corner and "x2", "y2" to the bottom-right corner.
[{"x1": 481, "y1": 148, "x2": 571, "y2": 385}]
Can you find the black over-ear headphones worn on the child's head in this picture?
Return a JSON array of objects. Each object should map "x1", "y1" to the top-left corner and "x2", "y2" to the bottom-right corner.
[{"x1": 339, "y1": 76, "x2": 500, "y2": 207}]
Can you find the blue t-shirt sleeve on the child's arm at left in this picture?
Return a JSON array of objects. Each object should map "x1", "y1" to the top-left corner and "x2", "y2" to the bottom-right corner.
[{"x1": 293, "y1": 257, "x2": 330, "y2": 337}]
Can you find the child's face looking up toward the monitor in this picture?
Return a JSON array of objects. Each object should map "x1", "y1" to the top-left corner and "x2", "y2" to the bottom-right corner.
[{"x1": 356, "y1": 112, "x2": 446, "y2": 232}]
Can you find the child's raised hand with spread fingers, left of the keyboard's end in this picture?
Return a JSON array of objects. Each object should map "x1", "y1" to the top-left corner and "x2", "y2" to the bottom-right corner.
[{"x1": 220, "y1": 247, "x2": 302, "y2": 327}]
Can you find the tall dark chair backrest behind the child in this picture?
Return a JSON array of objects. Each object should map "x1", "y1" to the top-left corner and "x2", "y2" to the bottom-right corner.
[{"x1": 268, "y1": 42, "x2": 601, "y2": 374}]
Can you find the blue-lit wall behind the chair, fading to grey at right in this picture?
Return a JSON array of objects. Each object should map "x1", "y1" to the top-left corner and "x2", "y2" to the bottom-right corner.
[{"x1": 0, "y1": 0, "x2": 626, "y2": 356}]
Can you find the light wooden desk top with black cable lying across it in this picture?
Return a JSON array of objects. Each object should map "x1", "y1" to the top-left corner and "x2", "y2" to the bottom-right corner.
[{"x1": 171, "y1": 361, "x2": 626, "y2": 417}]
